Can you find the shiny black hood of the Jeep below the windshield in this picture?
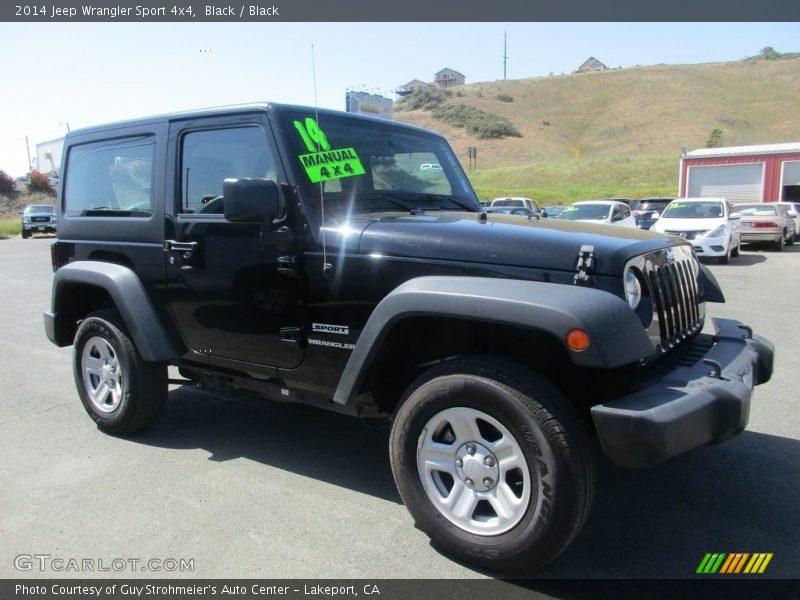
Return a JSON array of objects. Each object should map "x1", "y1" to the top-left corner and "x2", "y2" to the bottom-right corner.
[{"x1": 325, "y1": 211, "x2": 685, "y2": 276}]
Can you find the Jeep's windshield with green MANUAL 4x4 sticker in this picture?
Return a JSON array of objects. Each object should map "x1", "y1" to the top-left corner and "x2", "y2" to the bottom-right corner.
[{"x1": 280, "y1": 111, "x2": 479, "y2": 212}]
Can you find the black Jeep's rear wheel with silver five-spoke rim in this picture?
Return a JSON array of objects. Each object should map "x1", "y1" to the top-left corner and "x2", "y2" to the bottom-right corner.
[{"x1": 73, "y1": 309, "x2": 167, "y2": 435}]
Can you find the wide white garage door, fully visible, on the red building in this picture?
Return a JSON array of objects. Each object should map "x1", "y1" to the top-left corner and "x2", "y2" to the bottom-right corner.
[{"x1": 687, "y1": 163, "x2": 764, "y2": 202}]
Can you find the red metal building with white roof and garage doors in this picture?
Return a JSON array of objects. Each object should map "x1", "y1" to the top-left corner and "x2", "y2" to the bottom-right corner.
[{"x1": 678, "y1": 143, "x2": 800, "y2": 202}]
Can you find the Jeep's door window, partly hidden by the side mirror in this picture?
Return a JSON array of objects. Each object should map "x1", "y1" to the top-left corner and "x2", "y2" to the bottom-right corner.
[{"x1": 181, "y1": 126, "x2": 276, "y2": 214}]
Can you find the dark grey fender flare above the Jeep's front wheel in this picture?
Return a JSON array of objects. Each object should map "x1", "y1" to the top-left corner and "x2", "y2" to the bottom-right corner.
[{"x1": 333, "y1": 276, "x2": 654, "y2": 404}]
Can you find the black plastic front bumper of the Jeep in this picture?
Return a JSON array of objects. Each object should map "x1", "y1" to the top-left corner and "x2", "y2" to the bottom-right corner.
[{"x1": 592, "y1": 319, "x2": 775, "y2": 468}]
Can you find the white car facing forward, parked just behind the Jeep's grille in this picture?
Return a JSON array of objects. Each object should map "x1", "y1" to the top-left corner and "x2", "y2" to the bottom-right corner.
[{"x1": 650, "y1": 198, "x2": 742, "y2": 264}]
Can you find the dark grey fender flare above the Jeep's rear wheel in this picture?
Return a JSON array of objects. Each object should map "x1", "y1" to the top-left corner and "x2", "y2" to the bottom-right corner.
[{"x1": 45, "y1": 260, "x2": 178, "y2": 362}]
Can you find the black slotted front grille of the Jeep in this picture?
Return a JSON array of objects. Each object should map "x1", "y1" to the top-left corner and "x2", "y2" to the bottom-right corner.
[{"x1": 630, "y1": 245, "x2": 705, "y2": 352}]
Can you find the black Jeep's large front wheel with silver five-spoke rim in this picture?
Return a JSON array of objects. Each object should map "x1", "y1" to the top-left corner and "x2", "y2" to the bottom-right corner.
[{"x1": 390, "y1": 358, "x2": 595, "y2": 572}]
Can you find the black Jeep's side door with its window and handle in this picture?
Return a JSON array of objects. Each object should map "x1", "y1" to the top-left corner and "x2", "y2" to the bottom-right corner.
[{"x1": 165, "y1": 117, "x2": 303, "y2": 369}]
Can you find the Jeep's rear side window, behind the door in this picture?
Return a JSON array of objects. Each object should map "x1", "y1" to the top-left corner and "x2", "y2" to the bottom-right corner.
[{"x1": 64, "y1": 136, "x2": 156, "y2": 217}]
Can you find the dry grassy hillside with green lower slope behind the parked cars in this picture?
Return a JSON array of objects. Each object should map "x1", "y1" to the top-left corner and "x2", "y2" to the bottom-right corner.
[{"x1": 395, "y1": 54, "x2": 800, "y2": 201}]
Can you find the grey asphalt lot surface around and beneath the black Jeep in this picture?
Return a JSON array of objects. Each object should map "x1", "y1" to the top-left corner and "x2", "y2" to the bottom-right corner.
[{"x1": 0, "y1": 238, "x2": 800, "y2": 579}]
